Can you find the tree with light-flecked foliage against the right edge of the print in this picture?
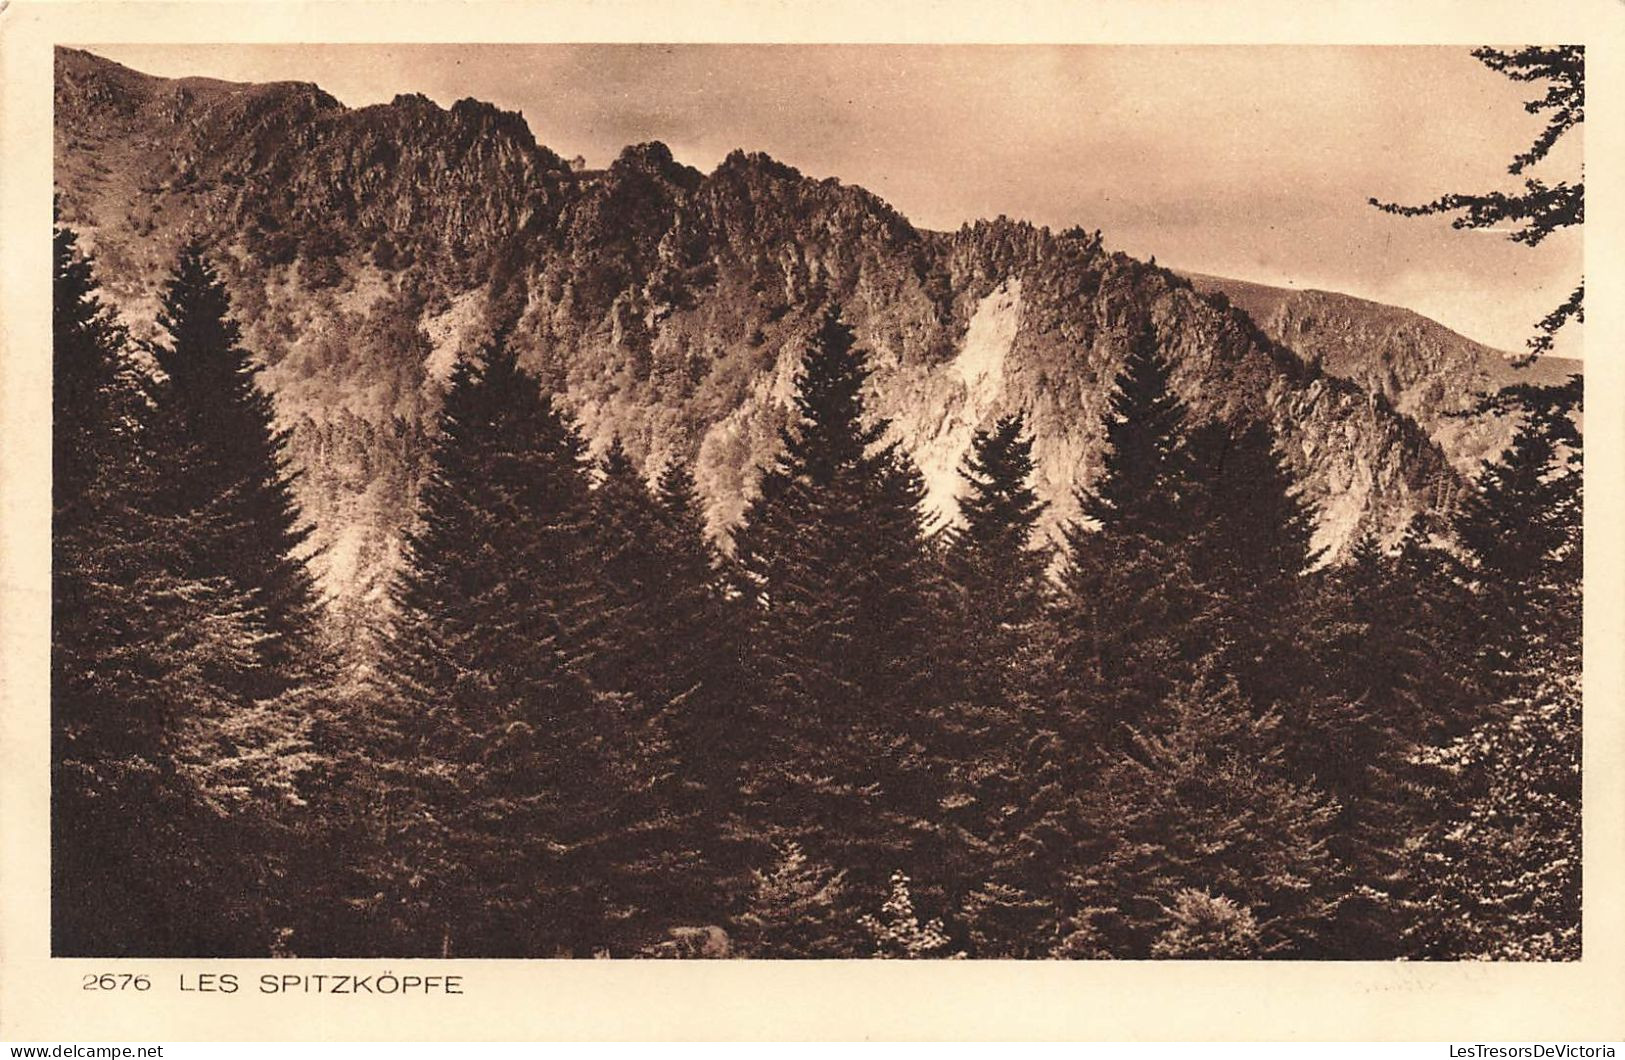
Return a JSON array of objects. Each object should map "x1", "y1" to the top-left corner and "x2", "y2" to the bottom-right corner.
[{"x1": 1407, "y1": 377, "x2": 1583, "y2": 961}]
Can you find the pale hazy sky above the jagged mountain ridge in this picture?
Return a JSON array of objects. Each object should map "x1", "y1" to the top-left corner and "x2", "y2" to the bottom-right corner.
[{"x1": 88, "y1": 44, "x2": 1581, "y2": 356}]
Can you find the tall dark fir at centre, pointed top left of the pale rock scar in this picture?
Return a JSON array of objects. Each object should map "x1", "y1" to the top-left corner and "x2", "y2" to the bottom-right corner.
[{"x1": 735, "y1": 311, "x2": 938, "y2": 919}]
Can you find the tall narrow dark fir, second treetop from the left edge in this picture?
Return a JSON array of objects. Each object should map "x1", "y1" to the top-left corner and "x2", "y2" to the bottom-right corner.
[{"x1": 150, "y1": 242, "x2": 320, "y2": 697}]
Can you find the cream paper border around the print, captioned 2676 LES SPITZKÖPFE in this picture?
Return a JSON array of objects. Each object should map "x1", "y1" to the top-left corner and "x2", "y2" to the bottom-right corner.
[{"x1": 0, "y1": 0, "x2": 1625, "y2": 1042}]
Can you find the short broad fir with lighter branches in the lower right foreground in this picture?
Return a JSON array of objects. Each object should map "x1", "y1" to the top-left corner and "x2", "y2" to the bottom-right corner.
[{"x1": 1063, "y1": 678, "x2": 1337, "y2": 958}]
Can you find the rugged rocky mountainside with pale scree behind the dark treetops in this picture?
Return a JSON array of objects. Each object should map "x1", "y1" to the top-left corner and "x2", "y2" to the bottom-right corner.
[{"x1": 57, "y1": 49, "x2": 1493, "y2": 613}]
